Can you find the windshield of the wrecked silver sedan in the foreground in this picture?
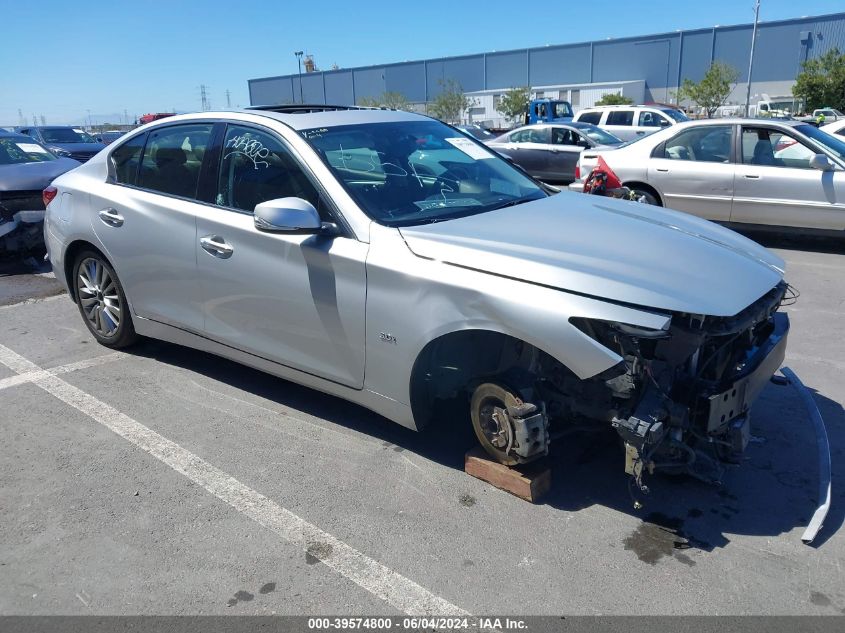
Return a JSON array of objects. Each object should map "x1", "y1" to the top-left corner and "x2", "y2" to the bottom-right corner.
[{"x1": 300, "y1": 121, "x2": 547, "y2": 226}]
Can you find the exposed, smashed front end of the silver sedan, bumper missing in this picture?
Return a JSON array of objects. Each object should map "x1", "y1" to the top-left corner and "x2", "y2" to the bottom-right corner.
[{"x1": 544, "y1": 282, "x2": 791, "y2": 492}]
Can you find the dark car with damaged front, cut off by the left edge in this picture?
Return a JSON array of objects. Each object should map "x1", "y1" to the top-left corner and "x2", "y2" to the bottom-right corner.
[{"x1": 0, "y1": 130, "x2": 79, "y2": 257}]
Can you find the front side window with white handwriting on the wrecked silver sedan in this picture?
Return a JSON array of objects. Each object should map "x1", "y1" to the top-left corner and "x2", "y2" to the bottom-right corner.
[{"x1": 215, "y1": 125, "x2": 319, "y2": 213}]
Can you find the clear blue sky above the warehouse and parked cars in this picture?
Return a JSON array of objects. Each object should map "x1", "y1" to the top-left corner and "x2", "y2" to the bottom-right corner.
[{"x1": 0, "y1": 0, "x2": 845, "y2": 125}]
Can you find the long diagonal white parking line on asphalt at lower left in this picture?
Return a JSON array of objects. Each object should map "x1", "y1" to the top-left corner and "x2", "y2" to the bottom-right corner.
[{"x1": 0, "y1": 344, "x2": 469, "y2": 616}]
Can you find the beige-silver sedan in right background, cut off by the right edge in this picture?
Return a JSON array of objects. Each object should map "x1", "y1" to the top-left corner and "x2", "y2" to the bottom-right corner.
[{"x1": 569, "y1": 119, "x2": 845, "y2": 235}]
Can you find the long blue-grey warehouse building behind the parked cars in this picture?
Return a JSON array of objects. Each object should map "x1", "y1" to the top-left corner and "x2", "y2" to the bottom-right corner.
[{"x1": 249, "y1": 13, "x2": 845, "y2": 125}]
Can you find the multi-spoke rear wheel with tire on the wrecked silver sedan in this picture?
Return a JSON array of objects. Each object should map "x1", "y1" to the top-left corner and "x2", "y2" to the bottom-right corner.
[{"x1": 73, "y1": 250, "x2": 138, "y2": 349}]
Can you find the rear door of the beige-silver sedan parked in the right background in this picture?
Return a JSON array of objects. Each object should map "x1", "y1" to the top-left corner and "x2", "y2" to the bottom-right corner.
[{"x1": 643, "y1": 125, "x2": 736, "y2": 222}]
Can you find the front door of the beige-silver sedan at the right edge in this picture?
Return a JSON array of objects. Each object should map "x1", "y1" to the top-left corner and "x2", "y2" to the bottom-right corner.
[{"x1": 731, "y1": 125, "x2": 845, "y2": 231}]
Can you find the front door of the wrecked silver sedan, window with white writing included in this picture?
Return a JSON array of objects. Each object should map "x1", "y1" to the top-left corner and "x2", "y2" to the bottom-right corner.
[{"x1": 195, "y1": 124, "x2": 368, "y2": 388}]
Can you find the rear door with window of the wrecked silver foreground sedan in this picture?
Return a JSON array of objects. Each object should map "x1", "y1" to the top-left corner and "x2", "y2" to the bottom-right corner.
[{"x1": 89, "y1": 122, "x2": 213, "y2": 332}]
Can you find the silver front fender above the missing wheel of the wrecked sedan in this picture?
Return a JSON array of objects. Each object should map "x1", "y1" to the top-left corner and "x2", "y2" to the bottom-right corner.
[{"x1": 365, "y1": 226, "x2": 669, "y2": 404}]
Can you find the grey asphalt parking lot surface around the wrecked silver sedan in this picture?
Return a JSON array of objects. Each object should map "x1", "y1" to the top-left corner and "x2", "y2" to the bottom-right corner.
[{"x1": 0, "y1": 232, "x2": 845, "y2": 615}]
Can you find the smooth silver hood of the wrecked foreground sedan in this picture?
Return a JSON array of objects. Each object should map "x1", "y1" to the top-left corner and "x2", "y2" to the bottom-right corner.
[{"x1": 400, "y1": 191, "x2": 784, "y2": 316}]
